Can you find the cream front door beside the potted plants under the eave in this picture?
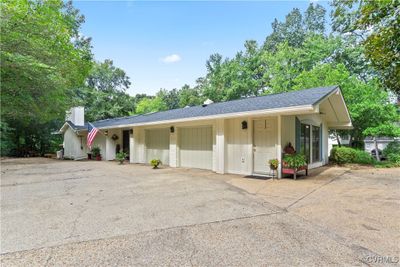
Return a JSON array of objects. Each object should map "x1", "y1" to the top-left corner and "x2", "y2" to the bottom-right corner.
[{"x1": 253, "y1": 117, "x2": 278, "y2": 174}]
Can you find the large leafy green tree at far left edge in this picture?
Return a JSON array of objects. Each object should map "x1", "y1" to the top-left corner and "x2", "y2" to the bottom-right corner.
[{"x1": 0, "y1": 0, "x2": 92, "y2": 156}]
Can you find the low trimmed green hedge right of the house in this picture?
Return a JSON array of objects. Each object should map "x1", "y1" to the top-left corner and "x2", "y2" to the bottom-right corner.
[{"x1": 330, "y1": 147, "x2": 374, "y2": 164}]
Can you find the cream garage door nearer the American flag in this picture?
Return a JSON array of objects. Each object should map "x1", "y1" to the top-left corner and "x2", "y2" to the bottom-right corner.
[{"x1": 145, "y1": 128, "x2": 169, "y2": 165}]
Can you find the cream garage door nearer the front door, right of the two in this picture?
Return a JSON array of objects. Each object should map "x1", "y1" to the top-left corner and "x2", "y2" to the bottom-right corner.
[{"x1": 179, "y1": 126, "x2": 213, "y2": 170}]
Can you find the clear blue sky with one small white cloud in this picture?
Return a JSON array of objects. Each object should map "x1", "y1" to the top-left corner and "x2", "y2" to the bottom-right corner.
[{"x1": 74, "y1": 0, "x2": 328, "y2": 95}]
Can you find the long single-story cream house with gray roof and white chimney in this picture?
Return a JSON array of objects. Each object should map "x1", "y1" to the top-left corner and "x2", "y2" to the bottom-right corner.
[{"x1": 60, "y1": 86, "x2": 352, "y2": 178}]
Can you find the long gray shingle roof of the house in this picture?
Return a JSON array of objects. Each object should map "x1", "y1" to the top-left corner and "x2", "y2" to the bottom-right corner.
[{"x1": 70, "y1": 86, "x2": 338, "y2": 129}]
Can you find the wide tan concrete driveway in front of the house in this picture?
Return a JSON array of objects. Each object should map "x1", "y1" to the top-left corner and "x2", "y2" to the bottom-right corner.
[{"x1": 1, "y1": 158, "x2": 400, "y2": 266}]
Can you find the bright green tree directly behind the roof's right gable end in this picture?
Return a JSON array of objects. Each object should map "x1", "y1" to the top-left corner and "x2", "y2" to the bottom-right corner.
[{"x1": 294, "y1": 64, "x2": 399, "y2": 146}]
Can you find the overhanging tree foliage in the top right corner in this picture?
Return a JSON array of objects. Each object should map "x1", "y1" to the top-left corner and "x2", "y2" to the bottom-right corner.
[{"x1": 332, "y1": 0, "x2": 400, "y2": 93}]
